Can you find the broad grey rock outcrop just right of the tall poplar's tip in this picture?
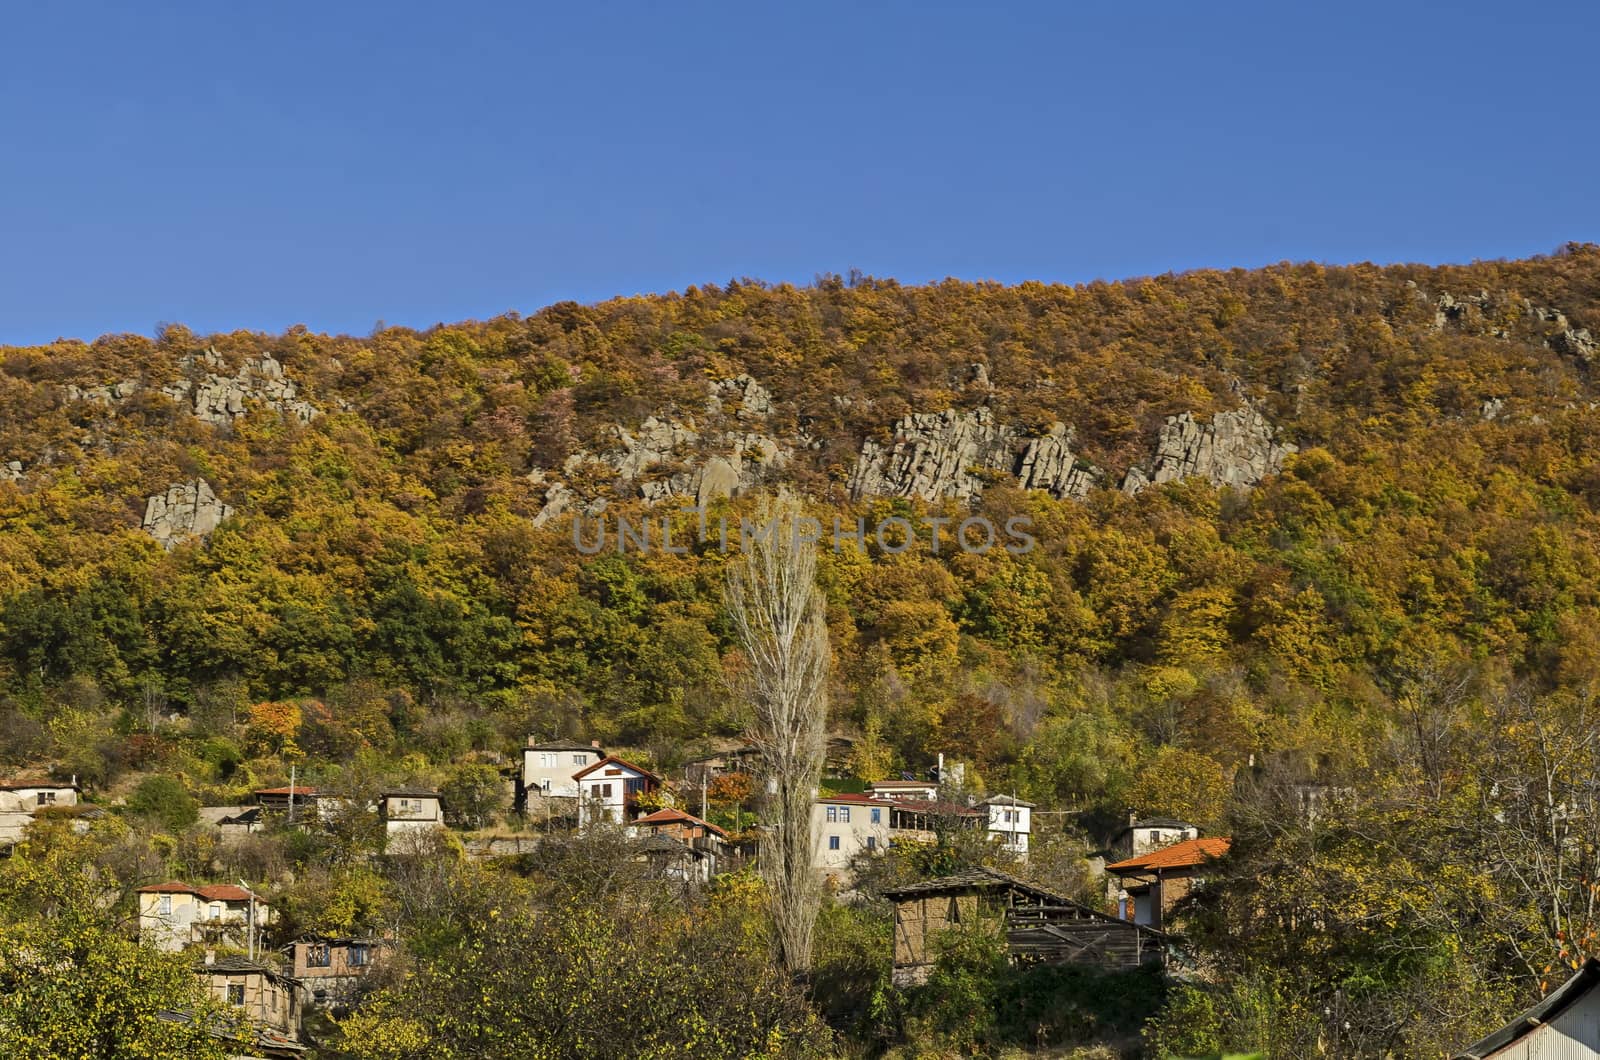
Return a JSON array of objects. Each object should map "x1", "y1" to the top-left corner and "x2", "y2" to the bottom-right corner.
[{"x1": 850, "y1": 408, "x2": 1022, "y2": 501}]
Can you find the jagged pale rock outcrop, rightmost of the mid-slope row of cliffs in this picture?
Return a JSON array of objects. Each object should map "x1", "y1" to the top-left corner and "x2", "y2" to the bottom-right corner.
[{"x1": 1122, "y1": 407, "x2": 1296, "y2": 493}]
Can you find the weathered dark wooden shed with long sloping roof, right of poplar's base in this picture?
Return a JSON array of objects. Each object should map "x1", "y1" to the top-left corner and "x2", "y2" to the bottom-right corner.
[{"x1": 885, "y1": 869, "x2": 1171, "y2": 986}]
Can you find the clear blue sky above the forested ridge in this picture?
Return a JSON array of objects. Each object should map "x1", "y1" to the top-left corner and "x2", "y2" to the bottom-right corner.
[{"x1": 0, "y1": 0, "x2": 1600, "y2": 343}]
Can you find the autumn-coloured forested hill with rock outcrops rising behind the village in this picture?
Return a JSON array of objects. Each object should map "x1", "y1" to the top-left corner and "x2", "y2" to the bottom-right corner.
[{"x1": 0, "y1": 245, "x2": 1600, "y2": 820}]
